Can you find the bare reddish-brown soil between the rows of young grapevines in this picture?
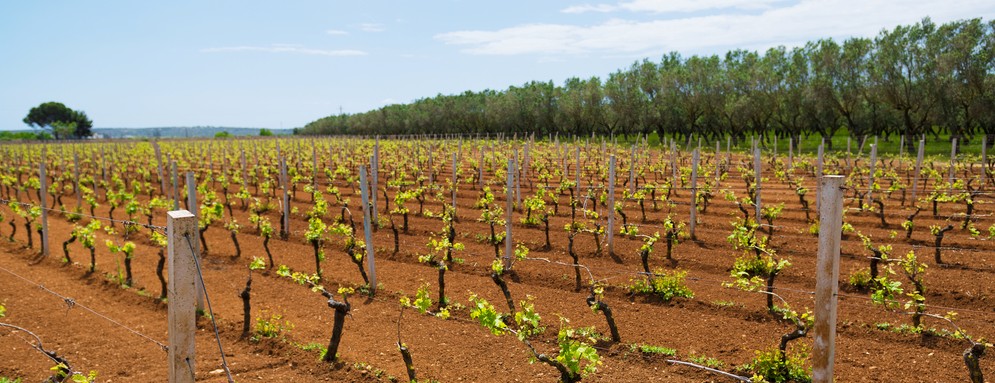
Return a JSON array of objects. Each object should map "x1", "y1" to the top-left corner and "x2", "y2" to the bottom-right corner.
[{"x1": 0, "y1": 148, "x2": 995, "y2": 382}]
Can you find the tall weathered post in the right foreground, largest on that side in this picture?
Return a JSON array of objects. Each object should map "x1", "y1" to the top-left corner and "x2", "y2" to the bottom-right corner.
[{"x1": 812, "y1": 176, "x2": 844, "y2": 383}]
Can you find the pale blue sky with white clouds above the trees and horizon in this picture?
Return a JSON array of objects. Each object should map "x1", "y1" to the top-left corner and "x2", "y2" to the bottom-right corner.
[{"x1": 0, "y1": 0, "x2": 995, "y2": 129}]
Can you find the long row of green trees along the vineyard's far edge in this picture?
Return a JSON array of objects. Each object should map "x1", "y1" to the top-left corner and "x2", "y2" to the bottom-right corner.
[{"x1": 298, "y1": 18, "x2": 995, "y2": 147}]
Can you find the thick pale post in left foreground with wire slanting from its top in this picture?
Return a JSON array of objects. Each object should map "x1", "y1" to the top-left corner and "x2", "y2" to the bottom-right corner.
[{"x1": 166, "y1": 210, "x2": 197, "y2": 383}]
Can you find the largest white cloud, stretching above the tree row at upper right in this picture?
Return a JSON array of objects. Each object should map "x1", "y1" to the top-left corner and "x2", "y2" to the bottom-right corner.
[{"x1": 435, "y1": 0, "x2": 995, "y2": 56}]
